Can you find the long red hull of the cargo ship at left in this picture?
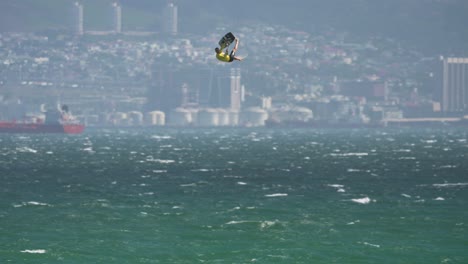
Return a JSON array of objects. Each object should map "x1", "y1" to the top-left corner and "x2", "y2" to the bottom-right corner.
[{"x1": 0, "y1": 122, "x2": 85, "y2": 134}]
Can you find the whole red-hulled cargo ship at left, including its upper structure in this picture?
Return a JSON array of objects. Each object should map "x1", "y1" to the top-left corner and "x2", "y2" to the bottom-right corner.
[{"x1": 0, "y1": 105, "x2": 85, "y2": 134}]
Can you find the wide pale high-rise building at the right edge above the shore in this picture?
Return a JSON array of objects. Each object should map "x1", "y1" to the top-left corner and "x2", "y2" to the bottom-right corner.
[{"x1": 442, "y1": 57, "x2": 468, "y2": 112}]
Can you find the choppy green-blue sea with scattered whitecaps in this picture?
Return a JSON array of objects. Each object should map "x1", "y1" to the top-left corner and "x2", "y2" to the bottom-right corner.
[{"x1": 0, "y1": 129, "x2": 468, "y2": 263}]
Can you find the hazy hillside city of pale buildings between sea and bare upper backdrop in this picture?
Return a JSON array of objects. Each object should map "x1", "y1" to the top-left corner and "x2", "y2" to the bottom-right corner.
[{"x1": 0, "y1": 20, "x2": 461, "y2": 126}]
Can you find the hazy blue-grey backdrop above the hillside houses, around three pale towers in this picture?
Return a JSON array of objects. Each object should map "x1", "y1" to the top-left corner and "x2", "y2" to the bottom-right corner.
[{"x1": 0, "y1": 0, "x2": 468, "y2": 53}]
